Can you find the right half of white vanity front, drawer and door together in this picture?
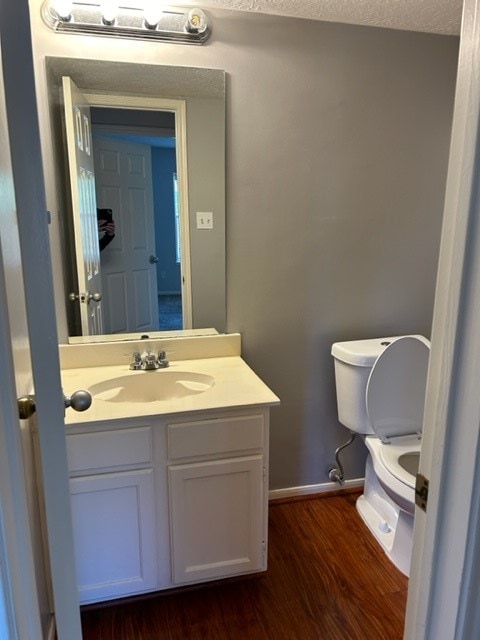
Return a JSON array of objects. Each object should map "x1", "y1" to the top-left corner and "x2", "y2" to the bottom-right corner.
[{"x1": 167, "y1": 413, "x2": 268, "y2": 584}]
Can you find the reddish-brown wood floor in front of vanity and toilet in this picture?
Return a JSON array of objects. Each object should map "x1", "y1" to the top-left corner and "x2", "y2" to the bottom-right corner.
[{"x1": 82, "y1": 493, "x2": 408, "y2": 640}]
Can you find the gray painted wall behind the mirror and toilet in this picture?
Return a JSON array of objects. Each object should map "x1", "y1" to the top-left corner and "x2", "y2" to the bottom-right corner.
[{"x1": 31, "y1": 11, "x2": 458, "y2": 488}]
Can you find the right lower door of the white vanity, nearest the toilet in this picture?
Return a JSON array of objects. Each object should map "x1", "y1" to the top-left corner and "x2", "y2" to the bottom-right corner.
[{"x1": 169, "y1": 455, "x2": 265, "y2": 584}]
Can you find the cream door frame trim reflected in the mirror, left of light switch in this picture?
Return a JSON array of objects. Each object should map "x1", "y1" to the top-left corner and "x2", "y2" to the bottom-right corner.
[{"x1": 82, "y1": 94, "x2": 193, "y2": 329}]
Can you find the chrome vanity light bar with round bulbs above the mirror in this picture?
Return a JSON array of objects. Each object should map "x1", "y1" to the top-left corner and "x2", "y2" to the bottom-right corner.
[{"x1": 42, "y1": 0, "x2": 212, "y2": 45}]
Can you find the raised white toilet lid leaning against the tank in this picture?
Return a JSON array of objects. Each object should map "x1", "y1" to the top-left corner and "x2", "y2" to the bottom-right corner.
[{"x1": 366, "y1": 336, "x2": 430, "y2": 440}]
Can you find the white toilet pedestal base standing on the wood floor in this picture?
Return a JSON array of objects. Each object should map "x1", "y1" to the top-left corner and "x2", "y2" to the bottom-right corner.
[{"x1": 356, "y1": 455, "x2": 413, "y2": 577}]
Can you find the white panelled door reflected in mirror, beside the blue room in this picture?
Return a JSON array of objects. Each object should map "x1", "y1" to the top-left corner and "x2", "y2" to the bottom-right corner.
[{"x1": 94, "y1": 136, "x2": 159, "y2": 333}]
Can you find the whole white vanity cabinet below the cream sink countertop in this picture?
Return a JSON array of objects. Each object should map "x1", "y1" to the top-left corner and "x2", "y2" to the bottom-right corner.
[{"x1": 67, "y1": 407, "x2": 269, "y2": 603}]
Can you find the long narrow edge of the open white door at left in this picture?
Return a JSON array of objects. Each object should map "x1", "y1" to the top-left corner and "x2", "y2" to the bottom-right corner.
[{"x1": 0, "y1": 0, "x2": 82, "y2": 640}]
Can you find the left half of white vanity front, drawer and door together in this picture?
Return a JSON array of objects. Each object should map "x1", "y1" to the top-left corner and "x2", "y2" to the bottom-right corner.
[{"x1": 67, "y1": 424, "x2": 157, "y2": 603}]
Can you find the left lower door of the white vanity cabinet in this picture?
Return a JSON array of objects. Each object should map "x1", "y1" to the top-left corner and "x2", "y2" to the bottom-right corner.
[{"x1": 70, "y1": 469, "x2": 156, "y2": 602}]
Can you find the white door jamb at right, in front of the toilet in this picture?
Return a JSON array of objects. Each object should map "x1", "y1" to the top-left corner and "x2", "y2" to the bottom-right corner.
[{"x1": 404, "y1": 0, "x2": 480, "y2": 640}]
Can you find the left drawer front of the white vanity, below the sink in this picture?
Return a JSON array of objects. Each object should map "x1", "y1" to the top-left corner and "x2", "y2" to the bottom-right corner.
[{"x1": 67, "y1": 426, "x2": 152, "y2": 473}]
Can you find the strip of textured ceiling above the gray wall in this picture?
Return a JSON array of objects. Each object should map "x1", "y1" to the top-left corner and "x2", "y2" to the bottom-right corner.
[{"x1": 181, "y1": 0, "x2": 462, "y2": 35}]
